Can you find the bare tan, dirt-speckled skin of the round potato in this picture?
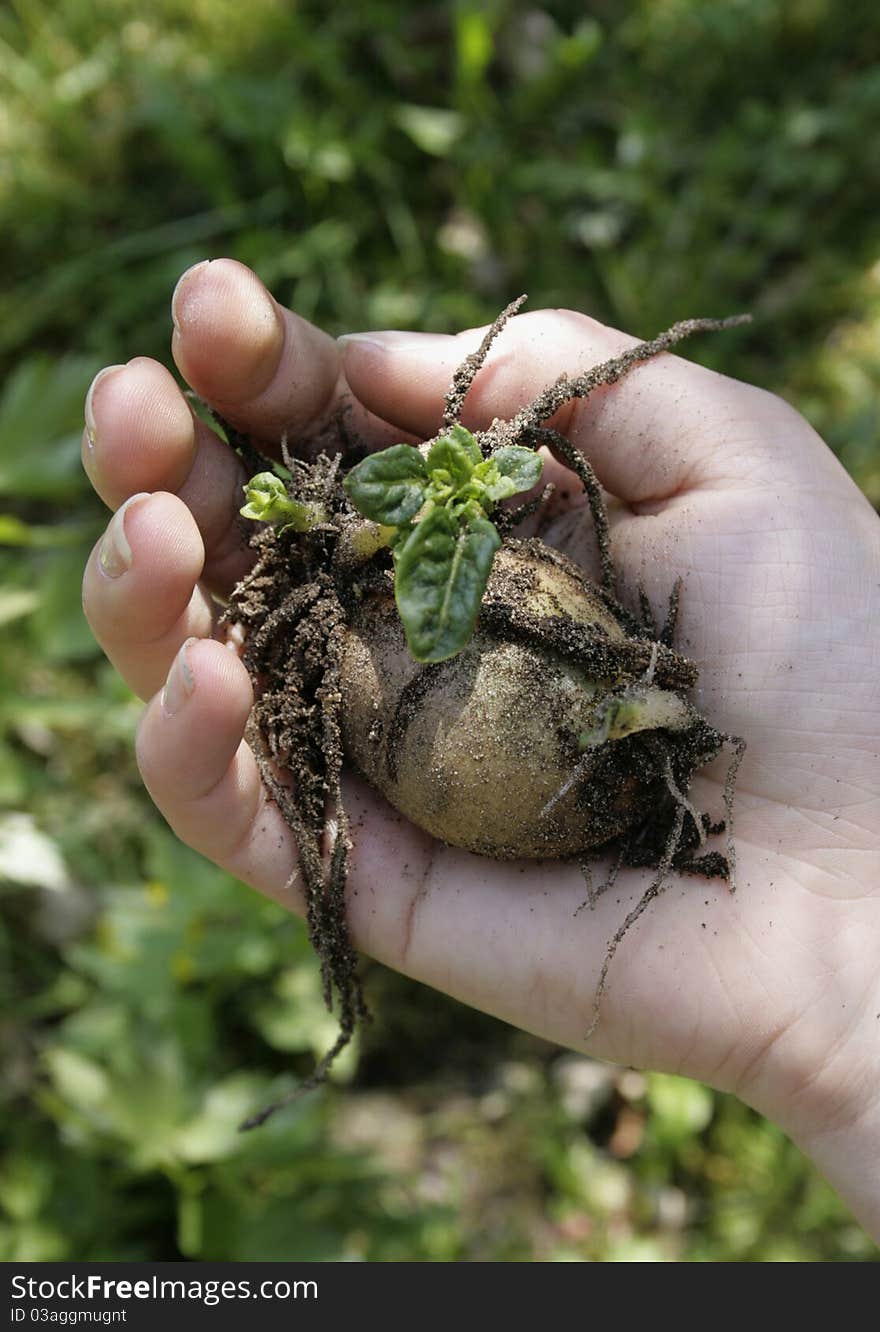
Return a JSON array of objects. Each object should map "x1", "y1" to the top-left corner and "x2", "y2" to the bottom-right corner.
[{"x1": 341, "y1": 541, "x2": 655, "y2": 859}]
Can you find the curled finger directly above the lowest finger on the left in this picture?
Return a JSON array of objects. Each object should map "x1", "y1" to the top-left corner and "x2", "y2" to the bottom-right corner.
[{"x1": 83, "y1": 493, "x2": 213, "y2": 698}]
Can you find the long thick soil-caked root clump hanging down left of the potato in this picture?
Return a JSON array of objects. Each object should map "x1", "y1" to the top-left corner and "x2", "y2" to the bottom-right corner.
[{"x1": 224, "y1": 514, "x2": 367, "y2": 1130}]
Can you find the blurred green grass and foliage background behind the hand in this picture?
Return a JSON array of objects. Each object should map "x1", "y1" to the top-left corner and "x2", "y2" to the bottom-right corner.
[{"x1": 0, "y1": 0, "x2": 880, "y2": 1261}]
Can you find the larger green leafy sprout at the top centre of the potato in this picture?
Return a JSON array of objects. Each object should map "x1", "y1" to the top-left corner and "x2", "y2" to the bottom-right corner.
[{"x1": 342, "y1": 425, "x2": 543, "y2": 662}]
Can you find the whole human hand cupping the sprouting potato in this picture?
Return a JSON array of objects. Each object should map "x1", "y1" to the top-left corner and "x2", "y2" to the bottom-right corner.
[{"x1": 84, "y1": 260, "x2": 880, "y2": 1232}]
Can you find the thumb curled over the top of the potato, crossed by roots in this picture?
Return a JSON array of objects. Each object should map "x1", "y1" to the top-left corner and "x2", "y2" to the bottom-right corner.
[{"x1": 342, "y1": 310, "x2": 825, "y2": 503}]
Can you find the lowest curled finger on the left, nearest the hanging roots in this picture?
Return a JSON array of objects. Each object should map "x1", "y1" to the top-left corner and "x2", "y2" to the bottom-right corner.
[{"x1": 137, "y1": 639, "x2": 302, "y2": 911}]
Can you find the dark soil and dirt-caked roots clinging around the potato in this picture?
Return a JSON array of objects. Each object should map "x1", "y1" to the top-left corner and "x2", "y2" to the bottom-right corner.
[{"x1": 224, "y1": 306, "x2": 744, "y2": 1128}]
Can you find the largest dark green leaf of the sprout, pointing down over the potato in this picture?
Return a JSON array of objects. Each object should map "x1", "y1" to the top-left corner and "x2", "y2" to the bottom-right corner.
[{"x1": 394, "y1": 507, "x2": 501, "y2": 662}]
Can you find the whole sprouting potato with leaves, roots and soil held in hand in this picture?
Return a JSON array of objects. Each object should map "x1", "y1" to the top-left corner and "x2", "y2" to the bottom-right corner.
[{"x1": 226, "y1": 301, "x2": 744, "y2": 1127}]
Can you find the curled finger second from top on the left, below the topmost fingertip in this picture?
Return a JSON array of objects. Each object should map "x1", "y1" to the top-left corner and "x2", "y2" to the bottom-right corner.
[{"x1": 83, "y1": 357, "x2": 253, "y2": 594}]
